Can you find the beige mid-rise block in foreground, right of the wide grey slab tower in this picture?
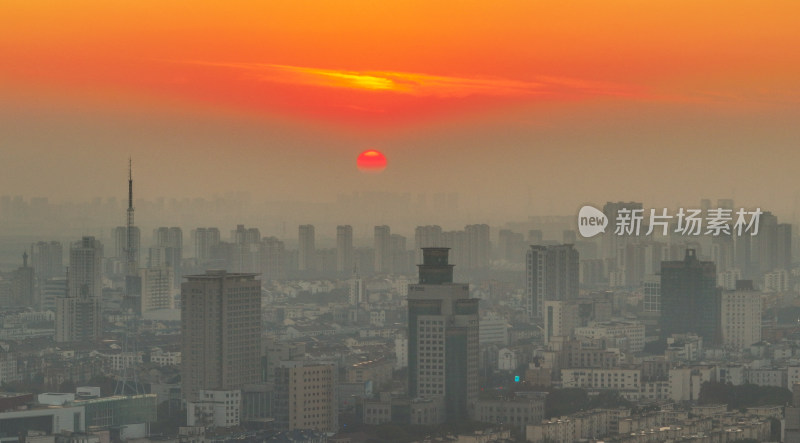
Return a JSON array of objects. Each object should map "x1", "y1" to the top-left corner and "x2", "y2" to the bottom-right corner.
[{"x1": 273, "y1": 361, "x2": 339, "y2": 432}]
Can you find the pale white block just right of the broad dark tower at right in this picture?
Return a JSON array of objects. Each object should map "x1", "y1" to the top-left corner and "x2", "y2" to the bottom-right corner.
[{"x1": 720, "y1": 291, "x2": 761, "y2": 350}]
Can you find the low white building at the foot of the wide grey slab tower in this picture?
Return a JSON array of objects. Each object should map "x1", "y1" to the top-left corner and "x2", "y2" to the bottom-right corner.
[{"x1": 186, "y1": 389, "x2": 242, "y2": 428}]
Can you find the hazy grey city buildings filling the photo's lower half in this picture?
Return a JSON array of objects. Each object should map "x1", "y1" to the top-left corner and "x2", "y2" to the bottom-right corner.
[{"x1": 0, "y1": 193, "x2": 800, "y2": 443}]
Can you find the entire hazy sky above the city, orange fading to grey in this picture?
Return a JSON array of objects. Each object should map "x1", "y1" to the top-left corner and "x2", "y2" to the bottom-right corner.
[{"x1": 0, "y1": 0, "x2": 800, "y2": 217}]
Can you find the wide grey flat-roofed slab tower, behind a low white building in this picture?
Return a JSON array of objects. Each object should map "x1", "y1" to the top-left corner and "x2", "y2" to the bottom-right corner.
[{"x1": 181, "y1": 271, "x2": 261, "y2": 401}]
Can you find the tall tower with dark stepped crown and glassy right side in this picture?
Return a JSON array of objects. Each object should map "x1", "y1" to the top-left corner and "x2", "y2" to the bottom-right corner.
[{"x1": 408, "y1": 248, "x2": 479, "y2": 420}]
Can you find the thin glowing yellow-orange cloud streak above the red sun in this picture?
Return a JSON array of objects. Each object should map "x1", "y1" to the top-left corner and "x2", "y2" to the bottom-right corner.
[{"x1": 172, "y1": 61, "x2": 641, "y2": 98}]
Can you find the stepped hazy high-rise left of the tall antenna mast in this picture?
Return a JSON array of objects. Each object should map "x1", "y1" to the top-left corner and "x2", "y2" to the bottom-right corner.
[{"x1": 55, "y1": 237, "x2": 103, "y2": 342}]
